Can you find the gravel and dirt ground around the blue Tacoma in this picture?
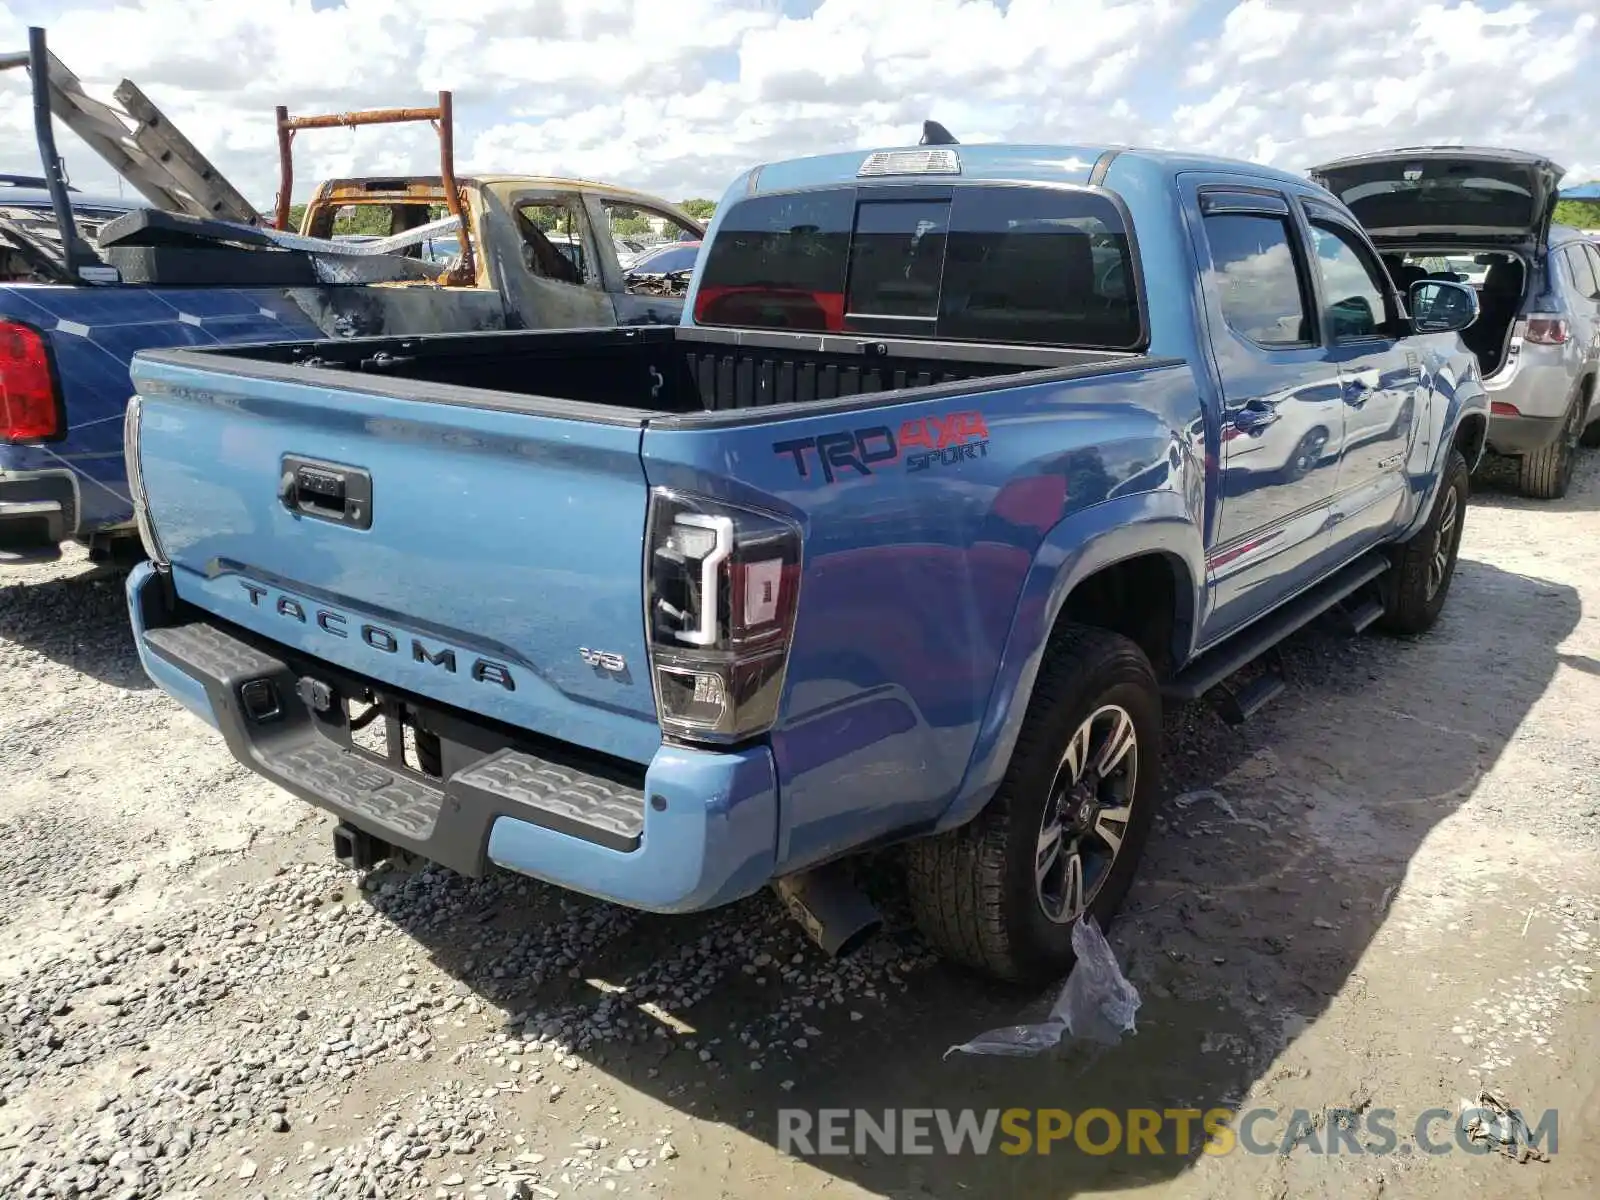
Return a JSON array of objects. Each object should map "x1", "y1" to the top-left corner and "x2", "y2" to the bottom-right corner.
[{"x1": 0, "y1": 454, "x2": 1600, "y2": 1200}]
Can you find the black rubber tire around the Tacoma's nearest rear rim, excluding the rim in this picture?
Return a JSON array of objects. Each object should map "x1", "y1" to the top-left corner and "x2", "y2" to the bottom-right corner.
[{"x1": 907, "y1": 624, "x2": 1162, "y2": 982}]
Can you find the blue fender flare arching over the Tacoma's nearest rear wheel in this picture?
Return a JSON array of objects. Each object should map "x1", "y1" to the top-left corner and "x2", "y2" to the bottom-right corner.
[{"x1": 938, "y1": 491, "x2": 1205, "y2": 830}]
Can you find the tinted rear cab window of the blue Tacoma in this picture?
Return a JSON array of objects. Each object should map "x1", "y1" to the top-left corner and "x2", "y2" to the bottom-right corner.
[{"x1": 694, "y1": 184, "x2": 1144, "y2": 350}]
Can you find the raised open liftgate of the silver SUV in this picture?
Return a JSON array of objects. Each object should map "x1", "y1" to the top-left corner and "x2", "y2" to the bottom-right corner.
[{"x1": 1309, "y1": 146, "x2": 1566, "y2": 248}]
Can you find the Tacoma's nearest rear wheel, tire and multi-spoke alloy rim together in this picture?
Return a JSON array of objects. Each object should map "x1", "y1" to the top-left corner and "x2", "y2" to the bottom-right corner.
[{"x1": 909, "y1": 626, "x2": 1162, "y2": 981}]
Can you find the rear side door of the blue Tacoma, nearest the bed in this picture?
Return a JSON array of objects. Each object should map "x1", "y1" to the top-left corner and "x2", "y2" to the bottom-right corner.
[{"x1": 1181, "y1": 181, "x2": 1344, "y2": 643}]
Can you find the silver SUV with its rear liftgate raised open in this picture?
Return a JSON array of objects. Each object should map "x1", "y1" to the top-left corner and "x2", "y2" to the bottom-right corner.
[{"x1": 1310, "y1": 146, "x2": 1600, "y2": 499}]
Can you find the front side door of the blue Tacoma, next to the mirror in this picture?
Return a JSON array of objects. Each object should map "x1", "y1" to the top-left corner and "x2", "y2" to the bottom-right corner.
[{"x1": 1301, "y1": 198, "x2": 1421, "y2": 554}]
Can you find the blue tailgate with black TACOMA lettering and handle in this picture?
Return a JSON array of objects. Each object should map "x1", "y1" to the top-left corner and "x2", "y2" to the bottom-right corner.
[{"x1": 134, "y1": 360, "x2": 661, "y2": 763}]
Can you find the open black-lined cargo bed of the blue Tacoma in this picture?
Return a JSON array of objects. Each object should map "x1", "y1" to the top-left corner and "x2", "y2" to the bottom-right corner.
[{"x1": 142, "y1": 326, "x2": 1142, "y2": 424}]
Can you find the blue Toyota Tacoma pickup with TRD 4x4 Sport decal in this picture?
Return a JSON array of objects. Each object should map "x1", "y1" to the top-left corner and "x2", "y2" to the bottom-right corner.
[{"x1": 126, "y1": 144, "x2": 1486, "y2": 979}]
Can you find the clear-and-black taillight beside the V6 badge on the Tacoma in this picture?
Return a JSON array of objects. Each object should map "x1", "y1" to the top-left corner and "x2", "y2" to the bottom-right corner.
[{"x1": 645, "y1": 488, "x2": 800, "y2": 742}]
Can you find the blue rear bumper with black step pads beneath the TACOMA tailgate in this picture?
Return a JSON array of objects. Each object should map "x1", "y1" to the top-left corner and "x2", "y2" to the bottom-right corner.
[{"x1": 128, "y1": 563, "x2": 778, "y2": 912}]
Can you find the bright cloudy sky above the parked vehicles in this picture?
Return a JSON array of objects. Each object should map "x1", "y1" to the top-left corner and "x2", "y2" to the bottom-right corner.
[{"x1": 0, "y1": 0, "x2": 1600, "y2": 208}]
